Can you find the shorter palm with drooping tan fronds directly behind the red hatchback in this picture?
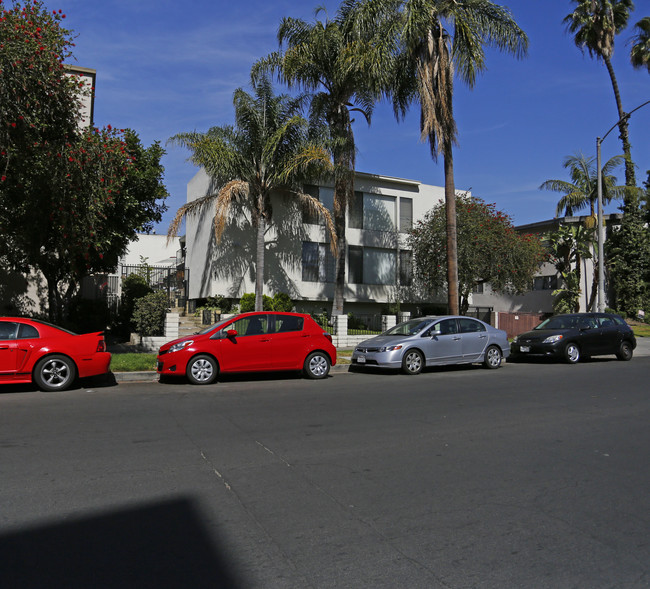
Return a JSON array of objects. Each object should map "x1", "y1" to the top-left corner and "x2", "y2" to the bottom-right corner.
[{"x1": 168, "y1": 77, "x2": 336, "y2": 311}]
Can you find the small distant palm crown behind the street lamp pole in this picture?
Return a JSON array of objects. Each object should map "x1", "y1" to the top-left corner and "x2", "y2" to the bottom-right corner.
[{"x1": 540, "y1": 153, "x2": 625, "y2": 217}]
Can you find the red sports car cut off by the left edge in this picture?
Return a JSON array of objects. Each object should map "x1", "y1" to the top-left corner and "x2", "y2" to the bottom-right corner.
[{"x1": 0, "y1": 317, "x2": 111, "y2": 391}]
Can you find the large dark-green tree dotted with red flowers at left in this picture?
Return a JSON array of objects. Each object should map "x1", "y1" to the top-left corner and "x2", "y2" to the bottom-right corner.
[{"x1": 0, "y1": 0, "x2": 167, "y2": 321}]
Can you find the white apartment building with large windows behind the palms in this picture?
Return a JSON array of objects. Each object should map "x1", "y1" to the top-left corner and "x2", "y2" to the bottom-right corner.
[{"x1": 185, "y1": 170, "x2": 456, "y2": 313}]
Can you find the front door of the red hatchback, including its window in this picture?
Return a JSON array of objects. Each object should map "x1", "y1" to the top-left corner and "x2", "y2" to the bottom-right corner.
[{"x1": 212, "y1": 313, "x2": 271, "y2": 372}]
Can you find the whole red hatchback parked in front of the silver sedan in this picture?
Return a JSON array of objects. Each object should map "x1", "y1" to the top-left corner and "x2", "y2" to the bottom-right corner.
[{"x1": 158, "y1": 311, "x2": 336, "y2": 384}]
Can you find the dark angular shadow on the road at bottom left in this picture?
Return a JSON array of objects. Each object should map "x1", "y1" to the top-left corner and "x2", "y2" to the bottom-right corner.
[{"x1": 0, "y1": 498, "x2": 244, "y2": 589}]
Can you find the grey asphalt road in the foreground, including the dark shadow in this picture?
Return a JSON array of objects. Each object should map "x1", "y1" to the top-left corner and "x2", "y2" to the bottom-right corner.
[{"x1": 0, "y1": 357, "x2": 650, "y2": 589}]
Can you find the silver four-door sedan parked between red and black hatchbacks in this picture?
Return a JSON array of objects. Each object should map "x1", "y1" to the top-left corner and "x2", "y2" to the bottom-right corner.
[{"x1": 352, "y1": 315, "x2": 510, "y2": 374}]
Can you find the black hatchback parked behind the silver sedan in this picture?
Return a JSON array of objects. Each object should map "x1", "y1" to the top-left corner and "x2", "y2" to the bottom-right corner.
[{"x1": 510, "y1": 313, "x2": 636, "y2": 364}]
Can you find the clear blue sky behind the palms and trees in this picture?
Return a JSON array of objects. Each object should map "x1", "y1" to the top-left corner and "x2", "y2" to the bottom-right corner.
[{"x1": 53, "y1": 0, "x2": 650, "y2": 233}]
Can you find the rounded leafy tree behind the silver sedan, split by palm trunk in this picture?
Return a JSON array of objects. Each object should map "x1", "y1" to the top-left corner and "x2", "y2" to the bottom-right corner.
[{"x1": 408, "y1": 196, "x2": 547, "y2": 313}]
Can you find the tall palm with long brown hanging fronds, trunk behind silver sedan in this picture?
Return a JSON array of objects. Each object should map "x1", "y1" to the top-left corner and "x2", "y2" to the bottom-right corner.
[{"x1": 346, "y1": 0, "x2": 528, "y2": 313}]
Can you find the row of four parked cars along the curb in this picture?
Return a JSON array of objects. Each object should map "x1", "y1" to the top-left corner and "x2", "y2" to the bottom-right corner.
[{"x1": 0, "y1": 312, "x2": 636, "y2": 391}]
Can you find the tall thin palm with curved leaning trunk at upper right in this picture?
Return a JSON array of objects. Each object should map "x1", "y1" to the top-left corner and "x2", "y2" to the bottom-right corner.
[{"x1": 563, "y1": 0, "x2": 636, "y2": 188}]
